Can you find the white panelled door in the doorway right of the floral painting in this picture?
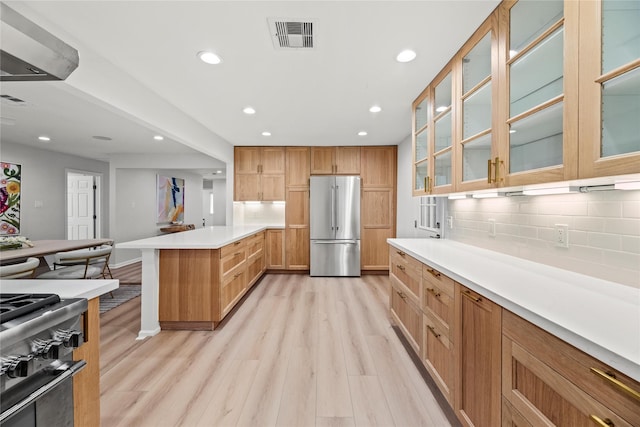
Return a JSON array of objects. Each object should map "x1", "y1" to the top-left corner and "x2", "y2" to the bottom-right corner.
[{"x1": 67, "y1": 173, "x2": 95, "y2": 240}]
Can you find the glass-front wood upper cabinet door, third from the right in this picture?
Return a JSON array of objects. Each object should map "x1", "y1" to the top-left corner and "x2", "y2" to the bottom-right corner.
[{"x1": 454, "y1": 14, "x2": 499, "y2": 191}]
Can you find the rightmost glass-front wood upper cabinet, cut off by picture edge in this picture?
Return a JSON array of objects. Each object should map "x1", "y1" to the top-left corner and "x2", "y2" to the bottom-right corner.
[{"x1": 579, "y1": 0, "x2": 640, "y2": 178}]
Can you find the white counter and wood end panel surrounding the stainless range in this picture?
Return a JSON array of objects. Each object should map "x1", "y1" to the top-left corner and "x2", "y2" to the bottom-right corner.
[{"x1": 2, "y1": 279, "x2": 119, "y2": 426}]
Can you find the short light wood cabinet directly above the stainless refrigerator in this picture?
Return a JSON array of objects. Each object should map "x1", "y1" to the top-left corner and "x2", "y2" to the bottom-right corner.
[{"x1": 311, "y1": 147, "x2": 360, "y2": 175}]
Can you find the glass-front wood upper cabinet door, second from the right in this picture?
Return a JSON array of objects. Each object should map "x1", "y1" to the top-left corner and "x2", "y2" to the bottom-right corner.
[{"x1": 502, "y1": 0, "x2": 582, "y2": 186}]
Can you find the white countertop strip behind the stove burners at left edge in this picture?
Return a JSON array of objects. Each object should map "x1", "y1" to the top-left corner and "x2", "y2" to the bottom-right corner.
[{"x1": 0, "y1": 279, "x2": 120, "y2": 300}]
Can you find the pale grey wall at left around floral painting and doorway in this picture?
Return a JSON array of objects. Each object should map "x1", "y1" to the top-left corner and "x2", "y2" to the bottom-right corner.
[{"x1": 0, "y1": 142, "x2": 111, "y2": 240}]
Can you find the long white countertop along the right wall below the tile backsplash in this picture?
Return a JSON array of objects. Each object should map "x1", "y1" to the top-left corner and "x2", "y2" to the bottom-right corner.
[{"x1": 387, "y1": 239, "x2": 640, "y2": 381}]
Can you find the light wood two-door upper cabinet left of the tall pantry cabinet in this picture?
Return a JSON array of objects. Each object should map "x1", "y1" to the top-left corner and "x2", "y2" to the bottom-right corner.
[{"x1": 234, "y1": 147, "x2": 285, "y2": 201}]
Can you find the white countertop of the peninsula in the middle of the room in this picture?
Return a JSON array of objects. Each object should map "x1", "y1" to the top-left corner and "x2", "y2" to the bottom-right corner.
[{"x1": 116, "y1": 225, "x2": 273, "y2": 249}]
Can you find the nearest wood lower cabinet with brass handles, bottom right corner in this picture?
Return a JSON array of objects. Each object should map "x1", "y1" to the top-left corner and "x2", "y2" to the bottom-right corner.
[{"x1": 502, "y1": 310, "x2": 640, "y2": 426}]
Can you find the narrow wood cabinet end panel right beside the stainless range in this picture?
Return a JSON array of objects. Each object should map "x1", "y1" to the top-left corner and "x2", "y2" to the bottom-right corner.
[{"x1": 73, "y1": 297, "x2": 100, "y2": 426}]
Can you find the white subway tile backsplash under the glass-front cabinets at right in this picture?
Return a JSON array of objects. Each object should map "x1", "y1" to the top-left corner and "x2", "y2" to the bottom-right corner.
[{"x1": 445, "y1": 191, "x2": 640, "y2": 288}]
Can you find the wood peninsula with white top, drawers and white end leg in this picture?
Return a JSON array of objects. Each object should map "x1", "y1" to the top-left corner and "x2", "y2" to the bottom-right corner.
[{"x1": 116, "y1": 225, "x2": 269, "y2": 339}]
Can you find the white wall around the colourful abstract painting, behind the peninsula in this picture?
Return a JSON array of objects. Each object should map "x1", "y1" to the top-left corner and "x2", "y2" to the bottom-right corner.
[{"x1": 112, "y1": 169, "x2": 202, "y2": 265}]
